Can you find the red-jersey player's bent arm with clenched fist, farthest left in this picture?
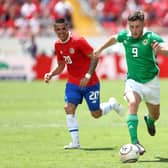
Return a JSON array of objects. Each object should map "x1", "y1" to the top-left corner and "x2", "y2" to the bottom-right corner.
[{"x1": 44, "y1": 61, "x2": 65, "y2": 83}]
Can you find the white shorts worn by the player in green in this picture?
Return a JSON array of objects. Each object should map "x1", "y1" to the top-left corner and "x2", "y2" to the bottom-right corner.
[{"x1": 124, "y1": 77, "x2": 160, "y2": 105}]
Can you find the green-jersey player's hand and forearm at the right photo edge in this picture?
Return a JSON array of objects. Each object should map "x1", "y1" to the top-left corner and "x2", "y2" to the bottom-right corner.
[{"x1": 152, "y1": 41, "x2": 168, "y2": 56}]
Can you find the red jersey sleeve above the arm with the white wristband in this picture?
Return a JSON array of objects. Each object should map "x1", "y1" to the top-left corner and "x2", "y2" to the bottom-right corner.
[{"x1": 77, "y1": 37, "x2": 93, "y2": 55}]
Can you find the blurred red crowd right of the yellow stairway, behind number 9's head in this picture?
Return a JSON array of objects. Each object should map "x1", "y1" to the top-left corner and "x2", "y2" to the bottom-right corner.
[{"x1": 86, "y1": 0, "x2": 168, "y2": 33}]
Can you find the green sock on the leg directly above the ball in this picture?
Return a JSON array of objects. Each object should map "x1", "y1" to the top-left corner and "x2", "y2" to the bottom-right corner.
[{"x1": 127, "y1": 114, "x2": 138, "y2": 144}]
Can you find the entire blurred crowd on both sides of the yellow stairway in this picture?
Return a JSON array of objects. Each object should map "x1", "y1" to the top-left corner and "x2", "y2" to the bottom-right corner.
[{"x1": 0, "y1": 0, "x2": 168, "y2": 37}]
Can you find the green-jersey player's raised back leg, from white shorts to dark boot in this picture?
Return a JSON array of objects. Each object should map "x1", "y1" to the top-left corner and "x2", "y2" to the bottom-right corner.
[{"x1": 144, "y1": 78, "x2": 160, "y2": 136}]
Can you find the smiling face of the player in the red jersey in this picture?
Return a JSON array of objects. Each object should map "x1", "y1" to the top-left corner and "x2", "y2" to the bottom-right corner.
[{"x1": 54, "y1": 23, "x2": 69, "y2": 41}]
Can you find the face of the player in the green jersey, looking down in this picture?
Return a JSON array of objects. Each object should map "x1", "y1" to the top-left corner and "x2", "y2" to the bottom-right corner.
[{"x1": 128, "y1": 20, "x2": 144, "y2": 39}]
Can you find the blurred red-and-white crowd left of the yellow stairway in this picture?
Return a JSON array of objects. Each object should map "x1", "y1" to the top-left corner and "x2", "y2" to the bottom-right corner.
[{"x1": 0, "y1": 0, "x2": 73, "y2": 38}]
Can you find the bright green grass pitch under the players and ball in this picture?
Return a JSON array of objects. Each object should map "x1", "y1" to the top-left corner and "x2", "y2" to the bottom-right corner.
[{"x1": 0, "y1": 80, "x2": 168, "y2": 168}]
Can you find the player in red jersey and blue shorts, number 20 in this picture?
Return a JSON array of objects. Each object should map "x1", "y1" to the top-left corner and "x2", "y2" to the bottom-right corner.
[{"x1": 44, "y1": 18, "x2": 123, "y2": 149}]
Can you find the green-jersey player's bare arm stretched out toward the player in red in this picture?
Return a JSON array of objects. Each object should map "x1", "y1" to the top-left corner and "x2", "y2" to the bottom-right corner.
[{"x1": 95, "y1": 36, "x2": 117, "y2": 56}]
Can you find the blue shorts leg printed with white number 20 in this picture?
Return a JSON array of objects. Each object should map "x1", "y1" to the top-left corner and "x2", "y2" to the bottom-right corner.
[{"x1": 84, "y1": 83, "x2": 100, "y2": 112}]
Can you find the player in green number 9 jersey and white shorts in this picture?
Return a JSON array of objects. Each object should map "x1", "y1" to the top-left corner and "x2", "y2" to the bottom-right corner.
[{"x1": 95, "y1": 11, "x2": 168, "y2": 155}]
